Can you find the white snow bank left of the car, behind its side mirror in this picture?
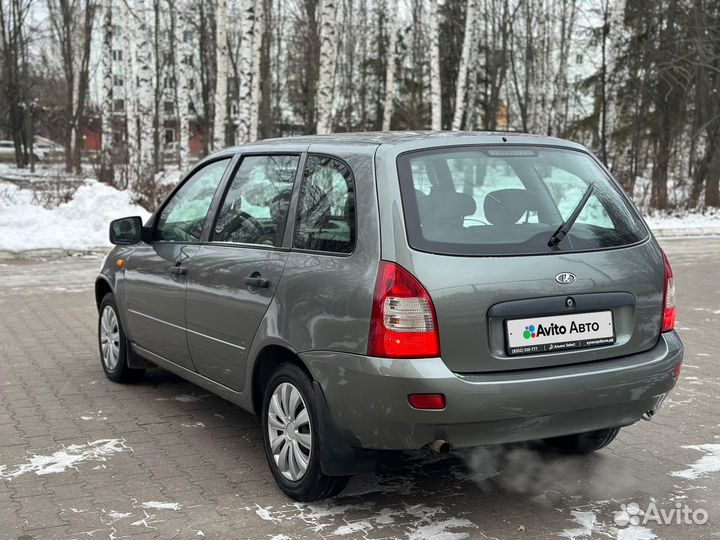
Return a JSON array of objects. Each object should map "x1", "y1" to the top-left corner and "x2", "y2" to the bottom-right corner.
[{"x1": 0, "y1": 180, "x2": 150, "y2": 251}]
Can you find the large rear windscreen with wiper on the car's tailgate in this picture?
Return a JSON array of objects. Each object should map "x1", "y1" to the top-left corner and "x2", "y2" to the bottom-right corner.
[{"x1": 398, "y1": 145, "x2": 648, "y2": 256}]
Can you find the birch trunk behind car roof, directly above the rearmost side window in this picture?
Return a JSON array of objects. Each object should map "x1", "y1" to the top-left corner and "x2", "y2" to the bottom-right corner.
[{"x1": 316, "y1": 0, "x2": 336, "y2": 135}]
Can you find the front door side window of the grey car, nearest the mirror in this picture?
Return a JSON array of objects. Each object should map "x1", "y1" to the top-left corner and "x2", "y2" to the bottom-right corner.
[{"x1": 154, "y1": 158, "x2": 230, "y2": 243}]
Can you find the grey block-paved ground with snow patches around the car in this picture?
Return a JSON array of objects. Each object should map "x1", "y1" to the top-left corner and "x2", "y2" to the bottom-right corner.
[{"x1": 0, "y1": 239, "x2": 720, "y2": 540}]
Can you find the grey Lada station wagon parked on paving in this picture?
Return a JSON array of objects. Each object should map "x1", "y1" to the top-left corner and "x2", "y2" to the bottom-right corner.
[{"x1": 95, "y1": 133, "x2": 683, "y2": 501}]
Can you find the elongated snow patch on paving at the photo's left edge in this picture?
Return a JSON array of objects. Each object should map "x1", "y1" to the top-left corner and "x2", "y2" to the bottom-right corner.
[{"x1": 0, "y1": 439, "x2": 126, "y2": 479}]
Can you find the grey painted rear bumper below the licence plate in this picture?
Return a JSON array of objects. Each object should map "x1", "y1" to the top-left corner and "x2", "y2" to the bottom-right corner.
[{"x1": 300, "y1": 332, "x2": 683, "y2": 449}]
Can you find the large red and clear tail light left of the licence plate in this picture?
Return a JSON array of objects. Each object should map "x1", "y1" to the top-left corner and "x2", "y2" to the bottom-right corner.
[{"x1": 368, "y1": 261, "x2": 440, "y2": 358}]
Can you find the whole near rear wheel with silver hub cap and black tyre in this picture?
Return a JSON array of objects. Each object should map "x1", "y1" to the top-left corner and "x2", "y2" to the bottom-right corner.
[{"x1": 262, "y1": 364, "x2": 348, "y2": 501}]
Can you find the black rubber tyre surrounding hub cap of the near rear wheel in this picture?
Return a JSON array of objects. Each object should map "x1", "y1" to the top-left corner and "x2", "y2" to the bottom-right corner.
[{"x1": 262, "y1": 363, "x2": 349, "y2": 502}]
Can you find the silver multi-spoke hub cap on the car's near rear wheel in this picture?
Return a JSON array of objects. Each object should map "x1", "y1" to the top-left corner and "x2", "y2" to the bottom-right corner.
[{"x1": 268, "y1": 383, "x2": 312, "y2": 481}]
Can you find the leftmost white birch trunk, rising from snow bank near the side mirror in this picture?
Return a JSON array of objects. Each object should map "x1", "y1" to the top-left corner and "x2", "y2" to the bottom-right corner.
[{"x1": 100, "y1": 0, "x2": 114, "y2": 184}]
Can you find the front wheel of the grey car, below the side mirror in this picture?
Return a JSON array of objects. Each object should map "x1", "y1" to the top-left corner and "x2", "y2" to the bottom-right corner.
[{"x1": 98, "y1": 293, "x2": 145, "y2": 382}]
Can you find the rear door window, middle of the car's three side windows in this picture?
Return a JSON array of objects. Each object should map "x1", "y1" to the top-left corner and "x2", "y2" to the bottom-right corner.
[{"x1": 211, "y1": 155, "x2": 300, "y2": 247}]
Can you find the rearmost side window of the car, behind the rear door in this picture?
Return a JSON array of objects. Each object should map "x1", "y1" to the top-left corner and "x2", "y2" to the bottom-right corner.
[{"x1": 293, "y1": 155, "x2": 355, "y2": 253}]
